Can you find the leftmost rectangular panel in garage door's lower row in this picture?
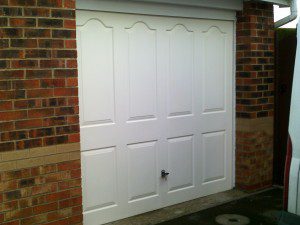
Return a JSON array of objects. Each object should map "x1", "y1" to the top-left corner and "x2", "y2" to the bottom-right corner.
[{"x1": 82, "y1": 147, "x2": 117, "y2": 211}]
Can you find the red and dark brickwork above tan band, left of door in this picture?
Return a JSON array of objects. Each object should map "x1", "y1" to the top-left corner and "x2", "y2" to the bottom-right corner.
[{"x1": 0, "y1": 0, "x2": 79, "y2": 152}]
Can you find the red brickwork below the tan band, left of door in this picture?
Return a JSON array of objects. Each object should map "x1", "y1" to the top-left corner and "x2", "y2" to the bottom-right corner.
[{"x1": 0, "y1": 150, "x2": 82, "y2": 225}]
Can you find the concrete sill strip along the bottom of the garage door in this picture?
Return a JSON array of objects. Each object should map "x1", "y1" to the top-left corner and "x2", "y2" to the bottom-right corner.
[{"x1": 107, "y1": 189, "x2": 250, "y2": 225}]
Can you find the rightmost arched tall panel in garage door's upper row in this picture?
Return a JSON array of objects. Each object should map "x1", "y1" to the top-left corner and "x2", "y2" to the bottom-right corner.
[{"x1": 203, "y1": 26, "x2": 227, "y2": 113}]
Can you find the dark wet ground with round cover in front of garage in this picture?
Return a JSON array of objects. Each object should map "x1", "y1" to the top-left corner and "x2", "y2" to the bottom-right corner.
[{"x1": 159, "y1": 189, "x2": 282, "y2": 225}]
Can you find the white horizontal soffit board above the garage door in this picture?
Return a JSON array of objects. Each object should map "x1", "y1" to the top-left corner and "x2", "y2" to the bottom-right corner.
[{"x1": 76, "y1": 0, "x2": 243, "y2": 20}]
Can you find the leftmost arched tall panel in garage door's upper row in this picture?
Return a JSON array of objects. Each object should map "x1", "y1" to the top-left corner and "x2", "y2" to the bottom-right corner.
[{"x1": 78, "y1": 19, "x2": 115, "y2": 125}]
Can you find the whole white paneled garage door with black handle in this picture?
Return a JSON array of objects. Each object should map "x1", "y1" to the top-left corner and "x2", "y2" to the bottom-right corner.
[{"x1": 77, "y1": 11, "x2": 233, "y2": 225}]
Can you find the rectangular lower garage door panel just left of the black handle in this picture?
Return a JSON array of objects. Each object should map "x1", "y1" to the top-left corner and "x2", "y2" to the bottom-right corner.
[{"x1": 128, "y1": 141, "x2": 158, "y2": 202}]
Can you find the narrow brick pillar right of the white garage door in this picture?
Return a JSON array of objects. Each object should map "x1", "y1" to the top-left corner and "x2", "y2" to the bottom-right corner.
[{"x1": 236, "y1": 2, "x2": 274, "y2": 190}]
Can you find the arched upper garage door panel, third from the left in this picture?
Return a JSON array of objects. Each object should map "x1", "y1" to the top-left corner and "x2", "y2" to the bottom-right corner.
[{"x1": 167, "y1": 24, "x2": 195, "y2": 118}]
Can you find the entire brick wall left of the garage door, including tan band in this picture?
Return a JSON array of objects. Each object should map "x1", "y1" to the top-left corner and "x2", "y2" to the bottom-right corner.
[{"x1": 0, "y1": 0, "x2": 82, "y2": 225}]
